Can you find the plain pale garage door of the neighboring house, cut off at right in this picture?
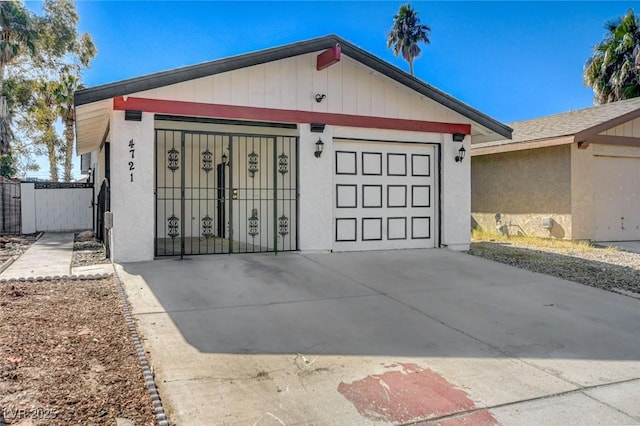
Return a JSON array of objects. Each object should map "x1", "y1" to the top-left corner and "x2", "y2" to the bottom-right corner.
[{"x1": 593, "y1": 157, "x2": 640, "y2": 241}]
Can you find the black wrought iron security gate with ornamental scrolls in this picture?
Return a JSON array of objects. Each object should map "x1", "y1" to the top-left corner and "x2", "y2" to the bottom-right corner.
[{"x1": 155, "y1": 129, "x2": 298, "y2": 256}]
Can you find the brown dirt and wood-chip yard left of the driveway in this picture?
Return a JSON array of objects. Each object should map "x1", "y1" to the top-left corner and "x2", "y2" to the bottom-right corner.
[{"x1": 0, "y1": 278, "x2": 155, "y2": 426}]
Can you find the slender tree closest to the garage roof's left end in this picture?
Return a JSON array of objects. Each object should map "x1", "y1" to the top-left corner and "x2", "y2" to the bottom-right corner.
[{"x1": 56, "y1": 70, "x2": 84, "y2": 182}]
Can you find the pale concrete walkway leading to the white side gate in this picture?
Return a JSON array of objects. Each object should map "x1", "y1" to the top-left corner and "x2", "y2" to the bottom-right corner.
[{"x1": 0, "y1": 232, "x2": 73, "y2": 279}]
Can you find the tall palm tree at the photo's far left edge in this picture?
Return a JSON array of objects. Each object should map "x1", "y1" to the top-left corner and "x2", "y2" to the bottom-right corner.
[{"x1": 0, "y1": 0, "x2": 36, "y2": 154}]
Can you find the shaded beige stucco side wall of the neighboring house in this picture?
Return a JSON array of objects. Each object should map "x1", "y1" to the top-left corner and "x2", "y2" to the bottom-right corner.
[{"x1": 471, "y1": 145, "x2": 573, "y2": 238}]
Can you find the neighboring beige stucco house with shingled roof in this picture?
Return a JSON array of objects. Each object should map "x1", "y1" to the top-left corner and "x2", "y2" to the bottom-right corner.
[{"x1": 471, "y1": 98, "x2": 640, "y2": 241}]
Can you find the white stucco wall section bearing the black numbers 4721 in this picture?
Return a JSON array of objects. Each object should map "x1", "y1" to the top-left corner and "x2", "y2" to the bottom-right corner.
[{"x1": 110, "y1": 111, "x2": 155, "y2": 262}]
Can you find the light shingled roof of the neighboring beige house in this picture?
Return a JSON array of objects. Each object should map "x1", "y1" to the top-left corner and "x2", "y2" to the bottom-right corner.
[{"x1": 473, "y1": 98, "x2": 640, "y2": 149}]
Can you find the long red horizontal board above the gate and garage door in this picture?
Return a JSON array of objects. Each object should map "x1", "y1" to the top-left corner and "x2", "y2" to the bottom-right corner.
[{"x1": 113, "y1": 96, "x2": 471, "y2": 135}]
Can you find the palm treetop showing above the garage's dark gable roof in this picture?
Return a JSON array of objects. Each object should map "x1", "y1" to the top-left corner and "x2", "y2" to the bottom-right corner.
[{"x1": 387, "y1": 3, "x2": 431, "y2": 75}]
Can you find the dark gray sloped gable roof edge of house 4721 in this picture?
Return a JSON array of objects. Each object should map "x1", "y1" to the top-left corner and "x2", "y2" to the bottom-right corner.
[{"x1": 74, "y1": 35, "x2": 511, "y2": 138}]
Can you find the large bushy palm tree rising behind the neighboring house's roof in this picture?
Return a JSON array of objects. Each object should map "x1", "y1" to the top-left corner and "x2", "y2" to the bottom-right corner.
[{"x1": 583, "y1": 9, "x2": 640, "y2": 104}]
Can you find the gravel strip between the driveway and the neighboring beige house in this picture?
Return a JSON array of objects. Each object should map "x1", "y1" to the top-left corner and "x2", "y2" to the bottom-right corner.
[{"x1": 468, "y1": 241, "x2": 640, "y2": 294}]
